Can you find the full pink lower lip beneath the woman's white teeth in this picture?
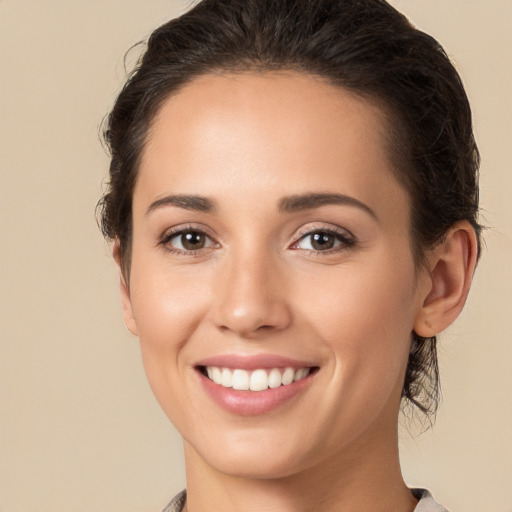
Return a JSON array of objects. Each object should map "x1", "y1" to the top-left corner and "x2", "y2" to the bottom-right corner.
[{"x1": 198, "y1": 372, "x2": 313, "y2": 416}]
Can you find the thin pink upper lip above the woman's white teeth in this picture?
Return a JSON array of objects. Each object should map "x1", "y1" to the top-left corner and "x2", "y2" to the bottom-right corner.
[{"x1": 196, "y1": 354, "x2": 317, "y2": 370}]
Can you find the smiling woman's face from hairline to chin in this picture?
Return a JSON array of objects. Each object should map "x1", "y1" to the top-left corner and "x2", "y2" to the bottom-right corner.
[{"x1": 123, "y1": 74, "x2": 424, "y2": 478}]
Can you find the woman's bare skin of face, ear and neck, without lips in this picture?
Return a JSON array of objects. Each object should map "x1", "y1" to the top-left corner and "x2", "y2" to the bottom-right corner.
[{"x1": 118, "y1": 73, "x2": 476, "y2": 512}]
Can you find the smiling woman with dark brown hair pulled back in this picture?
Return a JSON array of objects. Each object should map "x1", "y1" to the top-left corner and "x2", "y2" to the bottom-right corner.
[{"x1": 102, "y1": 0, "x2": 480, "y2": 512}]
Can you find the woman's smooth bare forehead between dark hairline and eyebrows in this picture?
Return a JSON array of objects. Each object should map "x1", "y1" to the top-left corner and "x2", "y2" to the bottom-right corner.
[{"x1": 136, "y1": 73, "x2": 404, "y2": 222}]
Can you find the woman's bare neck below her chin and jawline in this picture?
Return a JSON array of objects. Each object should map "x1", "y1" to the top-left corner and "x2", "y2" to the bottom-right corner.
[{"x1": 185, "y1": 420, "x2": 416, "y2": 512}]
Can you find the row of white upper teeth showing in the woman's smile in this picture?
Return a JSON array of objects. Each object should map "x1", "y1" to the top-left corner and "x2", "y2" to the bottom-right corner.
[{"x1": 206, "y1": 366, "x2": 311, "y2": 391}]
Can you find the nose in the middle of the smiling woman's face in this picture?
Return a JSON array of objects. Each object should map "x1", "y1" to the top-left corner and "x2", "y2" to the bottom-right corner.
[{"x1": 211, "y1": 250, "x2": 292, "y2": 338}]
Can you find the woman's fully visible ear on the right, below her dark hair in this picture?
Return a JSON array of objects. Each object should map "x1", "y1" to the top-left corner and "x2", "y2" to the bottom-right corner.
[{"x1": 414, "y1": 221, "x2": 478, "y2": 338}]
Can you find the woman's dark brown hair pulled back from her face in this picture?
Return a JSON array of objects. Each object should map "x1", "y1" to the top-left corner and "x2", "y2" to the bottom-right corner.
[{"x1": 98, "y1": 0, "x2": 480, "y2": 414}]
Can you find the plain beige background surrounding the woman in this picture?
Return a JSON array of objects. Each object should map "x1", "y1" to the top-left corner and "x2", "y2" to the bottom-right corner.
[{"x1": 0, "y1": 0, "x2": 512, "y2": 512}]
